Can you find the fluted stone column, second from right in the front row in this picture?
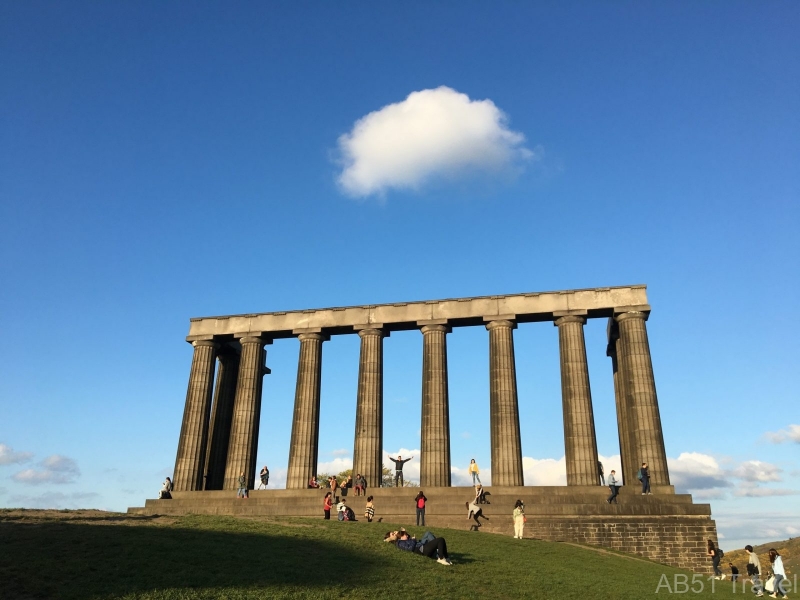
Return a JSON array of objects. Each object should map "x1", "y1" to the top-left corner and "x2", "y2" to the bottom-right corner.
[{"x1": 555, "y1": 315, "x2": 599, "y2": 485}]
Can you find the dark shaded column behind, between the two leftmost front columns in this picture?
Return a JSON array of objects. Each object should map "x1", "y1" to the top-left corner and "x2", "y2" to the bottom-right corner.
[{"x1": 205, "y1": 347, "x2": 239, "y2": 490}]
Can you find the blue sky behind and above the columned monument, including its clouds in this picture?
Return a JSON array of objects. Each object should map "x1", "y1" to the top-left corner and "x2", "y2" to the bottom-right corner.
[{"x1": 0, "y1": 2, "x2": 800, "y2": 544}]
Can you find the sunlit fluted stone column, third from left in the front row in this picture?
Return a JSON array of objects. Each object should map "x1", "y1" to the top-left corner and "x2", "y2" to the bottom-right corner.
[{"x1": 286, "y1": 333, "x2": 328, "y2": 489}]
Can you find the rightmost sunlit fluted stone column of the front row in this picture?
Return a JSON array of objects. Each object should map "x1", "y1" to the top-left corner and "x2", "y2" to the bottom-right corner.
[{"x1": 615, "y1": 311, "x2": 669, "y2": 485}]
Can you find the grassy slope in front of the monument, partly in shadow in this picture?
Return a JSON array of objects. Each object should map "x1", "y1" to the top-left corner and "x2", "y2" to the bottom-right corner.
[{"x1": 0, "y1": 511, "x2": 768, "y2": 600}]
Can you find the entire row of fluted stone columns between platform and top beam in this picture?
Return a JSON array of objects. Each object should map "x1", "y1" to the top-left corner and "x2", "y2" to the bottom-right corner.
[{"x1": 174, "y1": 311, "x2": 669, "y2": 491}]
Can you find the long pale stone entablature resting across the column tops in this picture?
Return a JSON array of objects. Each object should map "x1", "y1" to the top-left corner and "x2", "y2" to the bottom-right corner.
[{"x1": 186, "y1": 285, "x2": 650, "y2": 342}]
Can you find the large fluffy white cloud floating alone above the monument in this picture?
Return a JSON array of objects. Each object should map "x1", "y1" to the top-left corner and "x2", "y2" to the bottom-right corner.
[{"x1": 338, "y1": 86, "x2": 541, "y2": 197}]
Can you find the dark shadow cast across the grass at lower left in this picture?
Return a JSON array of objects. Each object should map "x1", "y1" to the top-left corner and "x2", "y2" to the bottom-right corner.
[{"x1": 0, "y1": 522, "x2": 382, "y2": 599}]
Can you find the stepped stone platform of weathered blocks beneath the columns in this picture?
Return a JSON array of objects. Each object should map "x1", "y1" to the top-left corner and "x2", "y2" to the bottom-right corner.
[{"x1": 128, "y1": 486, "x2": 717, "y2": 572}]
